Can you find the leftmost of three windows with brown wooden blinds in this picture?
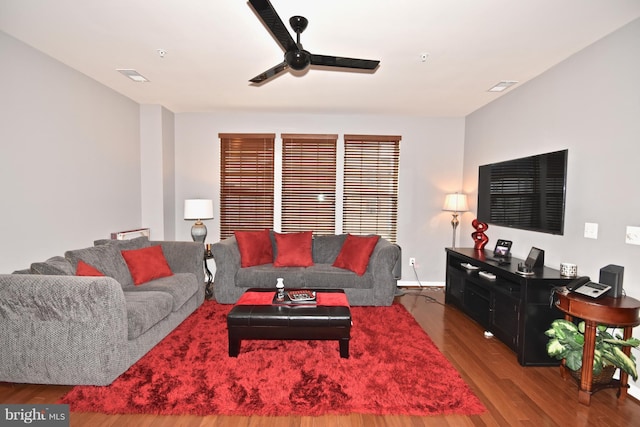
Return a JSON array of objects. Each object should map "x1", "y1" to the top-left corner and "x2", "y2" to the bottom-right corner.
[{"x1": 218, "y1": 134, "x2": 275, "y2": 239}]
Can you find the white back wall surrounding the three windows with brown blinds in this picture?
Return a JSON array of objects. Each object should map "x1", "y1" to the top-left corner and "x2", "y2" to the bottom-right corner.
[{"x1": 176, "y1": 112, "x2": 464, "y2": 284}]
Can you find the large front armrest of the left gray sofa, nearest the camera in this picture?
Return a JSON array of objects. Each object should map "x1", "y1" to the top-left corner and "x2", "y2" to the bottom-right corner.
[{"x1": 0, "y1": 274, "x2": 129, "y2": 385}]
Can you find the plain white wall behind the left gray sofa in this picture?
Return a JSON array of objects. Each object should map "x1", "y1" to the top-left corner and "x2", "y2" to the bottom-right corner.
[{"x1": 0, "y1": 32, "x2": 140, "y2": 273}]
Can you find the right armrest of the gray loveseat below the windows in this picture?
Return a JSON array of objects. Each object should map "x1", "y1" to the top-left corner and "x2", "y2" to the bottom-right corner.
[{"x1": 367, "y1": 238, "x2": 400, "y2": 301}]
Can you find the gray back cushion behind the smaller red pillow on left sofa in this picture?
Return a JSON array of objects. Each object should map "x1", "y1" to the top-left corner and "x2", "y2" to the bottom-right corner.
[{"x1": 64, "y1": 245, "x2": 133, "y2": 288}]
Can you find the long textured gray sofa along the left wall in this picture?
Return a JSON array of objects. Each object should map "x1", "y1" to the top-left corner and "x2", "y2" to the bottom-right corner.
[{"x1": 0, "y1": 237, "x2": 204, "y2": 385}]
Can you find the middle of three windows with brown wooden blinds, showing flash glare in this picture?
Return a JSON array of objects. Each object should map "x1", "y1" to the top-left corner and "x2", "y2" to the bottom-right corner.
[{"x1": 282, "y1": 134, "x2": 338, "y2": 234}]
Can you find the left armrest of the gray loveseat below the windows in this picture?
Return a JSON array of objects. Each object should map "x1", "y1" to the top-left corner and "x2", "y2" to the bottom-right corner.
[{"x1": 211, "y1": 236, "x2": 244, "y2": 304}]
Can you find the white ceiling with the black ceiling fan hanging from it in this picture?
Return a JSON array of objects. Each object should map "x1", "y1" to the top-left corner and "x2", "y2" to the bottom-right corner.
[{"x1": 0, "y1": 0, "x2": 640, "y2": 117}]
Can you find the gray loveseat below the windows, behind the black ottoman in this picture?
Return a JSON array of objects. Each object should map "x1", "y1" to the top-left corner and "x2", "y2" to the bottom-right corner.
[{"x1": 211, "y1": 234, "x2": 401, "y2": 306}]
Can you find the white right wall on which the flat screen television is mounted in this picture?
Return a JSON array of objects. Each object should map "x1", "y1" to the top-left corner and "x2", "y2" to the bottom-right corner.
[{"x1": 463, "y1": 20, "x2": 640, "y2": 394}]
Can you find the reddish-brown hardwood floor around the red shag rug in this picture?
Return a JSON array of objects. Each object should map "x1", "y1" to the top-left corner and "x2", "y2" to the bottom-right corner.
[{"x1": 0, "y1": 288, "x2": 640, "y2": 427}]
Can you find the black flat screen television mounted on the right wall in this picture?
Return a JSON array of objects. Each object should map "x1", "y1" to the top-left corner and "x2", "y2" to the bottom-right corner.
[{"x1": 478, "y1": 150, "x2": 568, "y2": 235}]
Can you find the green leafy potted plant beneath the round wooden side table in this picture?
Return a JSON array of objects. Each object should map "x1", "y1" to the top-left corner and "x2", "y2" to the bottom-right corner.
[{"x1": 545, "y1": 319, "x2": 640, "y2": 380}]
